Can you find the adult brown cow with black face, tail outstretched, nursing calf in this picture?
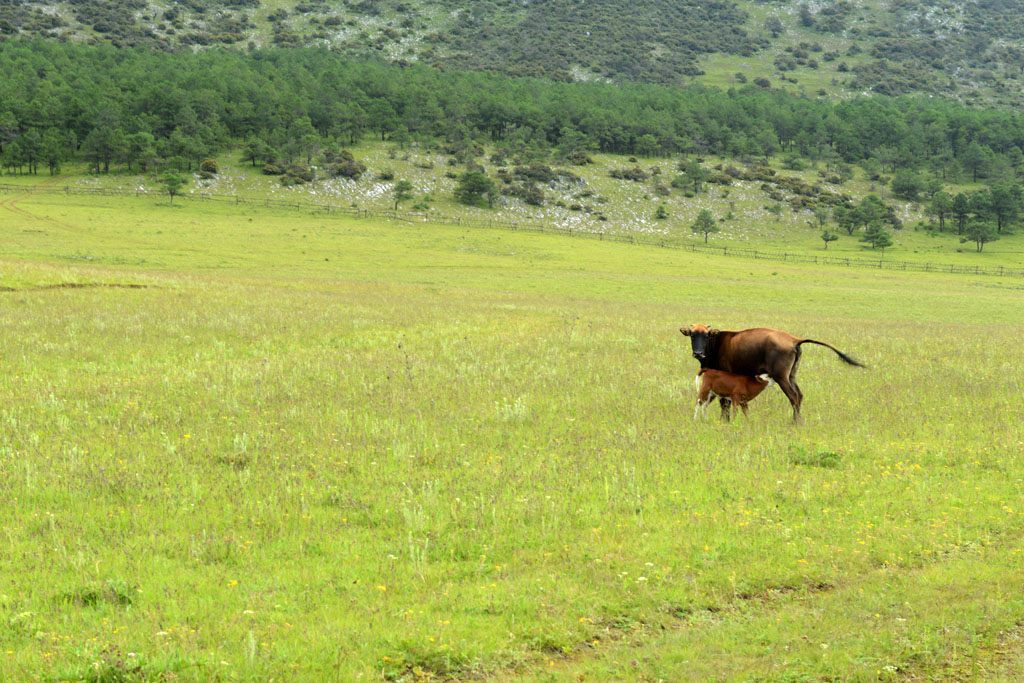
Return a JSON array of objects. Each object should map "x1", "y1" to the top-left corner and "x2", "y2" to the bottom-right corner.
[{"x1": 679, "y1": 325, "x2": 865, "y2": 422}]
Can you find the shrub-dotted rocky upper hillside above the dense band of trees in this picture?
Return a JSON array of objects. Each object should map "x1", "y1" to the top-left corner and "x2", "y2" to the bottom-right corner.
[{"x1": 6, "y1": 0, "x2": 1024, "y2": 105}]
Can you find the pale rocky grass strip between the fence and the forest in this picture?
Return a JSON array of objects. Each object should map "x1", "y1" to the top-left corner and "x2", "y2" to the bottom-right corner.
[{"x1": 0, "y1": 142, "x2": 1024, "y2": 268}]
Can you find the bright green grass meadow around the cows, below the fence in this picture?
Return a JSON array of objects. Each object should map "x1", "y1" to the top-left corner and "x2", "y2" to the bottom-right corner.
[{"x1": 0, "y1": 187, "x2": 1024, "y2": 681}]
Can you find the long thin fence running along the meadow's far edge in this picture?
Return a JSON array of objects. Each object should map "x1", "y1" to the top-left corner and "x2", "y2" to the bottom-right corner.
[{"x1": 6, "y1": 183, "x2": 1024, "y2": 278}]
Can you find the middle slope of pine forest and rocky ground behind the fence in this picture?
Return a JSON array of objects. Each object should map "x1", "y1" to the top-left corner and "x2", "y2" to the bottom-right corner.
[{"x1": 0, "y1": 40, "x2": 1024, "y2": 258}]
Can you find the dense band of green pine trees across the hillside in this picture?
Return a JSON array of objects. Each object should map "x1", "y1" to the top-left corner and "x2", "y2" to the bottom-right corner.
[{"x1": 0, "y1": 40, "x2": 1024, "y2": 187}]
